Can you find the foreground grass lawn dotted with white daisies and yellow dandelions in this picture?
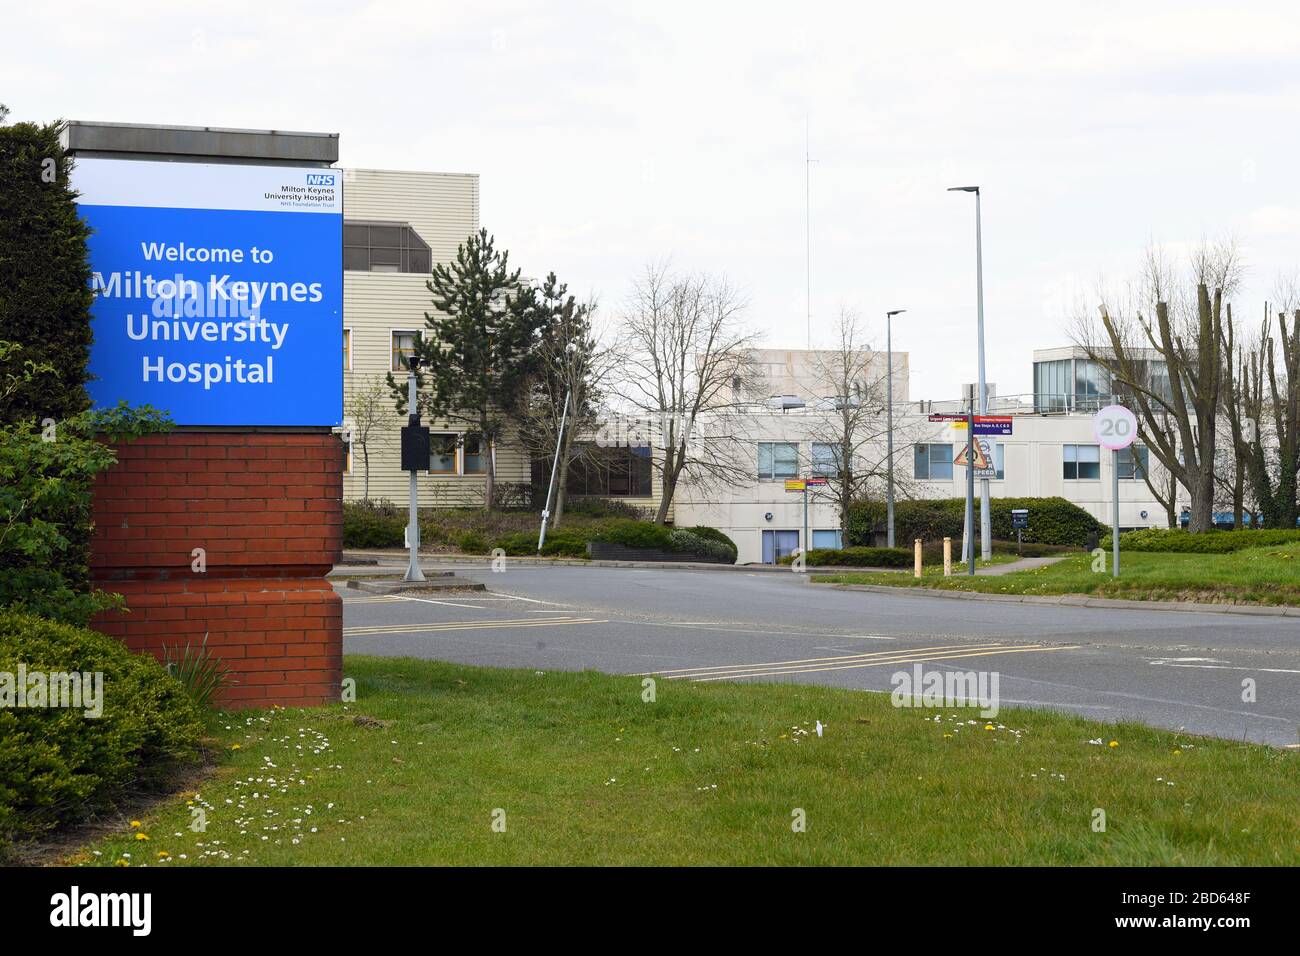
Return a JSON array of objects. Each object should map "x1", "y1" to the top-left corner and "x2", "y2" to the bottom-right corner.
[{"x1": 69, "y1": 657, "x2": 1300, "y2": 866}]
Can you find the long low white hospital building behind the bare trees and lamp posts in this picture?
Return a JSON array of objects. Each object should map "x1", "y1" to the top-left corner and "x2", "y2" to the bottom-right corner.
[{"x1": 675, "y1": 349, "x2": 1185, "y2": 563}]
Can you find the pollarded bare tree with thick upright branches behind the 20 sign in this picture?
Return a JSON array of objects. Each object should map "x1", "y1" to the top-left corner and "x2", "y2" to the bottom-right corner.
[{"x1": 1074, "y1": 242, "x2": 1242, "y2": 532}]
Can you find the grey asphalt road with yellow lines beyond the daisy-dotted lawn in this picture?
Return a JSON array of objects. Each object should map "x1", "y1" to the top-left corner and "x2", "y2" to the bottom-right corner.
[{"x1": 338, "y1": 566, "x2": 1300, "y2": 745}]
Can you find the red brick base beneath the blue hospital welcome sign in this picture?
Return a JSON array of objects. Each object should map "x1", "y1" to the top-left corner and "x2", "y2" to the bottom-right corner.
[{"x1": 91, "y1": 432, "x2": 345, "y2": 706}]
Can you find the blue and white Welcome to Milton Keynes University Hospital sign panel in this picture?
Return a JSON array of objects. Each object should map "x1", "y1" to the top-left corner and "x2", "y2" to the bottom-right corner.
[{"x1": 74, "y1": 159, "x2": 343, "y2": 425}]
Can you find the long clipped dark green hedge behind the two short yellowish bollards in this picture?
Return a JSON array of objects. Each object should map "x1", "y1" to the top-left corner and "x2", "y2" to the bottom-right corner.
[{"x1": 845, "y1": 498, "x2": 1109, "y2": 548}]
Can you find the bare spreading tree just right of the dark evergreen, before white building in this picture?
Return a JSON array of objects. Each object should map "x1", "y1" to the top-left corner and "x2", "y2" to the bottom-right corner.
[{"x1": 620, "y1": 265, "x2": 757, "y2": 524}]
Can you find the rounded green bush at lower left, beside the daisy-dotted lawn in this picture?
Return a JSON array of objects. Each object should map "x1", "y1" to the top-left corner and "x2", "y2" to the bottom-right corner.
[{"x1": 0, "y1": 611, "x2": 203, "y2": 856}]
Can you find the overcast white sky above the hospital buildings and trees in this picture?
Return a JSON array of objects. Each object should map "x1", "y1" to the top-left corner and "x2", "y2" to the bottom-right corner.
[{"x1": 10, "y1": 0, "x2": 1300, "y2": 398}]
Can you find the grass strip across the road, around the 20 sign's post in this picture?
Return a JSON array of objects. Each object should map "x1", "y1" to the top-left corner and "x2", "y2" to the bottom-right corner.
[{"x1": 813, "y1": 544, "x2": 1300, "y2": 606}]
